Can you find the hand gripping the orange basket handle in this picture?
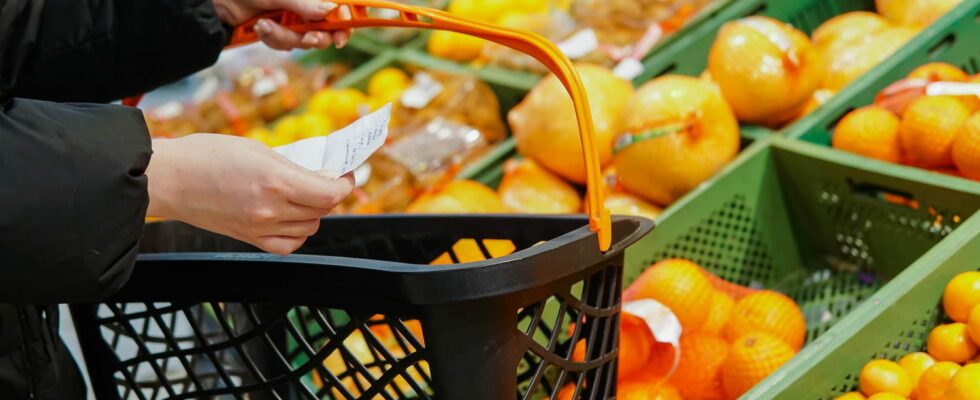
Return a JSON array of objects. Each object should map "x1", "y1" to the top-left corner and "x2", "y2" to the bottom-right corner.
[{"x1": 214, "y1": 0, "x2": 351, "y2": 50}]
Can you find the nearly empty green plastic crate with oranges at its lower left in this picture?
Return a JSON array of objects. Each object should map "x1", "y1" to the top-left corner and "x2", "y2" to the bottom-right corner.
[{"x1": 624, "y1": 136, "x2": 980, "y2": 399}]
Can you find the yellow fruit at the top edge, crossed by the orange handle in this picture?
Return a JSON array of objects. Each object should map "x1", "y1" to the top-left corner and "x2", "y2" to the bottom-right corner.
[{"x1": 428, "y1": 0, "x2": 570, "y2": 62}]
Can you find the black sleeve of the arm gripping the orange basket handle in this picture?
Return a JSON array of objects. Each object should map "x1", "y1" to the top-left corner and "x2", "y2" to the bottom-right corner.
[{"x1": 0, "y1": 0, "x2": 230, "y2": 102}]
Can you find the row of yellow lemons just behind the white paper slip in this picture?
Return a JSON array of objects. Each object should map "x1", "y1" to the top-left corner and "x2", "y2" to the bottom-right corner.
[{"x1": 246, "y1": 67, "x2": 411, "y2": 147}]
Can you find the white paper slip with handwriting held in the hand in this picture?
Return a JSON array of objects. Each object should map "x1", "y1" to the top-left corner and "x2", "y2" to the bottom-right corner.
[{"x1": 273, "y1": 104, "x2": 391, "y2": 176}]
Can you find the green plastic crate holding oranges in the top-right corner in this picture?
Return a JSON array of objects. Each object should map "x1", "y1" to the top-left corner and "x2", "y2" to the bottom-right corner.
[{"x1": 786, "y1": 0, "x2": 980, "y2": 146}]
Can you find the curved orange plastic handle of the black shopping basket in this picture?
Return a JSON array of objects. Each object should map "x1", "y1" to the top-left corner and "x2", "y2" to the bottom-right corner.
[{"x1": 134, "y1": 0, "x2": 612, "y2": 251}]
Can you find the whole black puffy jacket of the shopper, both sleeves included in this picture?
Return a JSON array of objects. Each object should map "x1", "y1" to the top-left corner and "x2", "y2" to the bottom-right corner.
[{"x1": 0, "y1": 0, "x2": 229, "y2": 399}]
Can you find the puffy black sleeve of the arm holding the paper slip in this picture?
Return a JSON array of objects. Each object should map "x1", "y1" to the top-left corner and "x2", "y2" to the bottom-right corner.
[{"x1": 0, "y1": 99, "x2": 151, "y2": 304}]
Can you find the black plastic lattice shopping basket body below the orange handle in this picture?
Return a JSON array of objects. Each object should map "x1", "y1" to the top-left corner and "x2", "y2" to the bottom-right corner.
[{"x1": 71, "y1": 215, "x2": 653, "y2": 399}]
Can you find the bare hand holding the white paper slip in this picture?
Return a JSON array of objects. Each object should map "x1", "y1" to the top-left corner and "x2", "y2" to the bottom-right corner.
[{"x1": 146, "y1": 134, "x2": 354, "y2": 255}]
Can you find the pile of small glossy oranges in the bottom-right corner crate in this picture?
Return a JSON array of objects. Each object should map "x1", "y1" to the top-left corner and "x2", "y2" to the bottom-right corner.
[{"x1": 836, "y1": 271, "x2": 980, "y2": 400}]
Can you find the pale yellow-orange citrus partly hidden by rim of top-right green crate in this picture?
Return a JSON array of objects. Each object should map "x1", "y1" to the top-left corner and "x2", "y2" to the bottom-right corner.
[{"x1": 823, "y1": 27, "x2": 918, "y2": 91}]
